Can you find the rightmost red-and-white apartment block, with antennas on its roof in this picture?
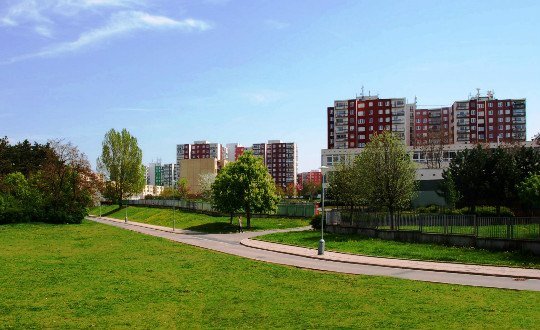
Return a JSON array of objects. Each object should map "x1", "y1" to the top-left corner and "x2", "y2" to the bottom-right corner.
[{"x1": 452, "y1": 92, "x2": 526, "y2": 144}]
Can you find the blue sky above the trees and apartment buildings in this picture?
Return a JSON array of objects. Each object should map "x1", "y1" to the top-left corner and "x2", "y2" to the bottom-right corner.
[{"x1": 0, "y1": 0, "x2": 540, "y2": 171}]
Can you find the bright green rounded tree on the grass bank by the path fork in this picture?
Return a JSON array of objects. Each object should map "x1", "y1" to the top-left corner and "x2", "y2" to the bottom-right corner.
[{"x1": 212, "y1": 151, "x2": 279, "y2": 228}]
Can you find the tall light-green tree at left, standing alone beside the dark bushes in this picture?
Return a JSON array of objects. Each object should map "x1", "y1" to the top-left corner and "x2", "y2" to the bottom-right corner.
[{"x1": 97, "y1": 128, "x2": 145, "y2": 206}]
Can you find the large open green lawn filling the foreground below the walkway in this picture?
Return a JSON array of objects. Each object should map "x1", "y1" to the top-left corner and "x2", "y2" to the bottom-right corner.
[{"x1": 0, "y1": 221, "x2": 540, "y2": 329}]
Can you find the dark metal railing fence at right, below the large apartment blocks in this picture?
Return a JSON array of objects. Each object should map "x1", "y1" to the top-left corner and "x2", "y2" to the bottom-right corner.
[{"x1": 326, "y1": 211, "x2": 540, "y2": 240}]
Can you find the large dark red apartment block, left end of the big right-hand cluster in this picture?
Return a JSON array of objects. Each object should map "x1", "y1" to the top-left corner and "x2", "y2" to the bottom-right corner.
[{"x1": 327, "y1": 96, "x2": 415, "y2": 149}]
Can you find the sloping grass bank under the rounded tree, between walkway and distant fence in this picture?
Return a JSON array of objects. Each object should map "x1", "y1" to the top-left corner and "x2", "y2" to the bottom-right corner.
[{"x1": 90, "y1": 206, "x2": 309, "y2": 233}]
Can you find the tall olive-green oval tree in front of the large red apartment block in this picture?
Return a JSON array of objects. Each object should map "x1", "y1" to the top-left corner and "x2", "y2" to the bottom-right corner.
[{"x1": 355, "y1": 131, "x2": 416, "y2": 228}]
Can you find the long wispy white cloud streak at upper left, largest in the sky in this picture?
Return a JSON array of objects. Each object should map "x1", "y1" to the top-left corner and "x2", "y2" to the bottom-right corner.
[{"x1": 4, "y1": 11, "x2": 211, "y2": 64}]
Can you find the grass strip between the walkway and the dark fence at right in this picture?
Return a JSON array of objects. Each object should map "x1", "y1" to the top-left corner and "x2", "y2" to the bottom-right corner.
[{"x1": 256, "y1": 230, "x2": 540, "y2": 268}]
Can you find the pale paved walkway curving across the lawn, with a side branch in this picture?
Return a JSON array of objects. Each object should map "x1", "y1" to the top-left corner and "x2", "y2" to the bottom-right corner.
[{"x1": 88, "y1": 217, "x2": 540, "y2": 291}]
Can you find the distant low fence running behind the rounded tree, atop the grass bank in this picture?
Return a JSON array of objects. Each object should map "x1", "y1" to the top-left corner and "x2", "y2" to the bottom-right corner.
[{"x1": 124, "y1": 199, "x2": 316, "y2": 218}]
